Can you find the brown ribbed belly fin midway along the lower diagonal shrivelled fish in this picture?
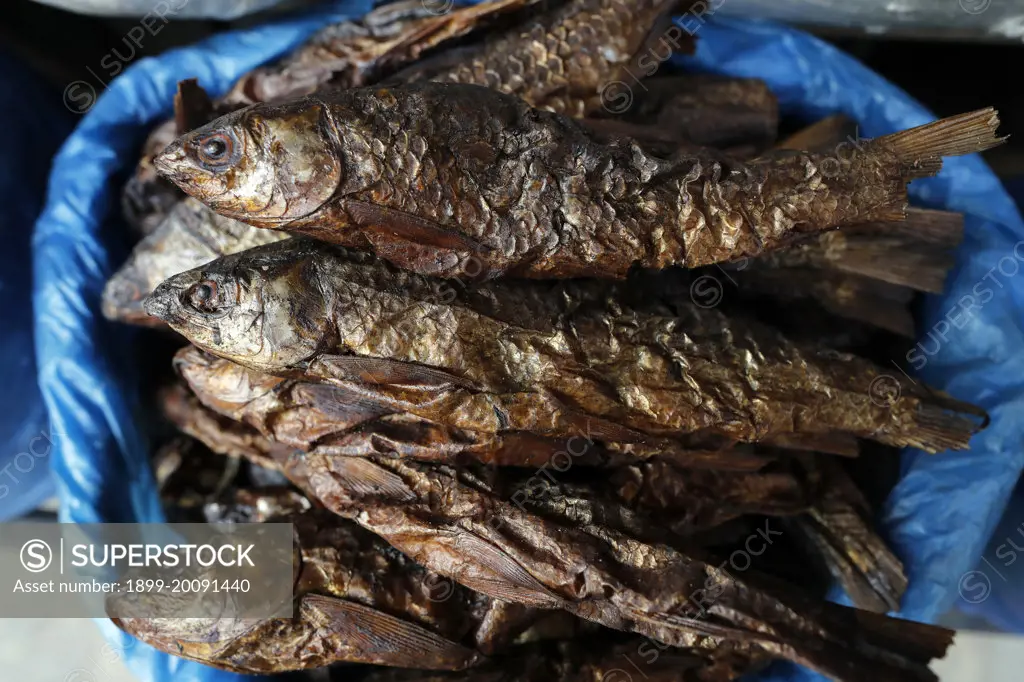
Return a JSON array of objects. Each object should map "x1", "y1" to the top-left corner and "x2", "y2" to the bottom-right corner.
[{"x1": 453, "y1": 528, "x2": 565, "y2": 608}]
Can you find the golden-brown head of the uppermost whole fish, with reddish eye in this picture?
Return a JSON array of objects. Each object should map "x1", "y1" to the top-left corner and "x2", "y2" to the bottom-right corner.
[{"x1": 154, "y1": 99, "x2": 343, "y2": 227}]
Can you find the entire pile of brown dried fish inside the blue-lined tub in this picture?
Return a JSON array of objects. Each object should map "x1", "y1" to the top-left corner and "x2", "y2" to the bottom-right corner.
[{"x1": 103, "y1": 0, "x2": 1000, "y2": 682}]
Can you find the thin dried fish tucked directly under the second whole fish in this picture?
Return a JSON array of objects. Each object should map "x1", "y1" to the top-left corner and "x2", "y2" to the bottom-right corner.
[{"x1": 174, "y1": 347, "x2": 806, "y2": 471}]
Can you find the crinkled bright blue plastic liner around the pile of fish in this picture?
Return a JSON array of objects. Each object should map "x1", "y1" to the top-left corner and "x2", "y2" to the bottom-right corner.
[{"x1": 35, "y1": 3, "x2": 1024, "y2": 682}]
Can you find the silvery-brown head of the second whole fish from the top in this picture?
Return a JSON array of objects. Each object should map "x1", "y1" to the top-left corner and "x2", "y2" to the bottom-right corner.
[{"x1": 144, "y1": 240, "x2": 330, "y2": 373}]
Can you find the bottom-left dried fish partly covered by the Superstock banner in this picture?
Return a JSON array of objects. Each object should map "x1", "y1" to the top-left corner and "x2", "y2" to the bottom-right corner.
[{"x1": 112, "y1": 510, "x2": 572, "y2": 673}]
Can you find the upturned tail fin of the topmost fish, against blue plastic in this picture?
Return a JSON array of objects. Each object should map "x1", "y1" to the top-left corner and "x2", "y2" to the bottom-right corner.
[{"x1": 870, "y1": 106, "x2": 1007, "y2": 179}]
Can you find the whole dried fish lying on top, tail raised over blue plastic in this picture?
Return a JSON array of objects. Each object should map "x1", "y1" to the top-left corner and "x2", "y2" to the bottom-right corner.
[{"x1": 156, "y1": 83, "x2": 999, "y2": 278}]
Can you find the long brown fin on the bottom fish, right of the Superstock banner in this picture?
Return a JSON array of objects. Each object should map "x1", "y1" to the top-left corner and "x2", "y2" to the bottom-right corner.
[{"x1": 299, "y1": 594, "x2": 484, "y2": 670}]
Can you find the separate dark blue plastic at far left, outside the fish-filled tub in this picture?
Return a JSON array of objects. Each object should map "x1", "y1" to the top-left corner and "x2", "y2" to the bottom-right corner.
[{"x1": 0, "y1": 51, "x2": 73, "y2": 521}]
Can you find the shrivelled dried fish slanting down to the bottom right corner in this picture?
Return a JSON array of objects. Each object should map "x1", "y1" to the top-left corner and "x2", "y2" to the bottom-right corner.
[{"x1": 299, "y1": 456, "x2": 952, "y2": 682}]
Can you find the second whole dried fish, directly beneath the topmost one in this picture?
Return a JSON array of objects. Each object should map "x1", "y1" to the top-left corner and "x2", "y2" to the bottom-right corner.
[{"x1": 145, "y1": 239, "x2": 984, "y2": 452}]
